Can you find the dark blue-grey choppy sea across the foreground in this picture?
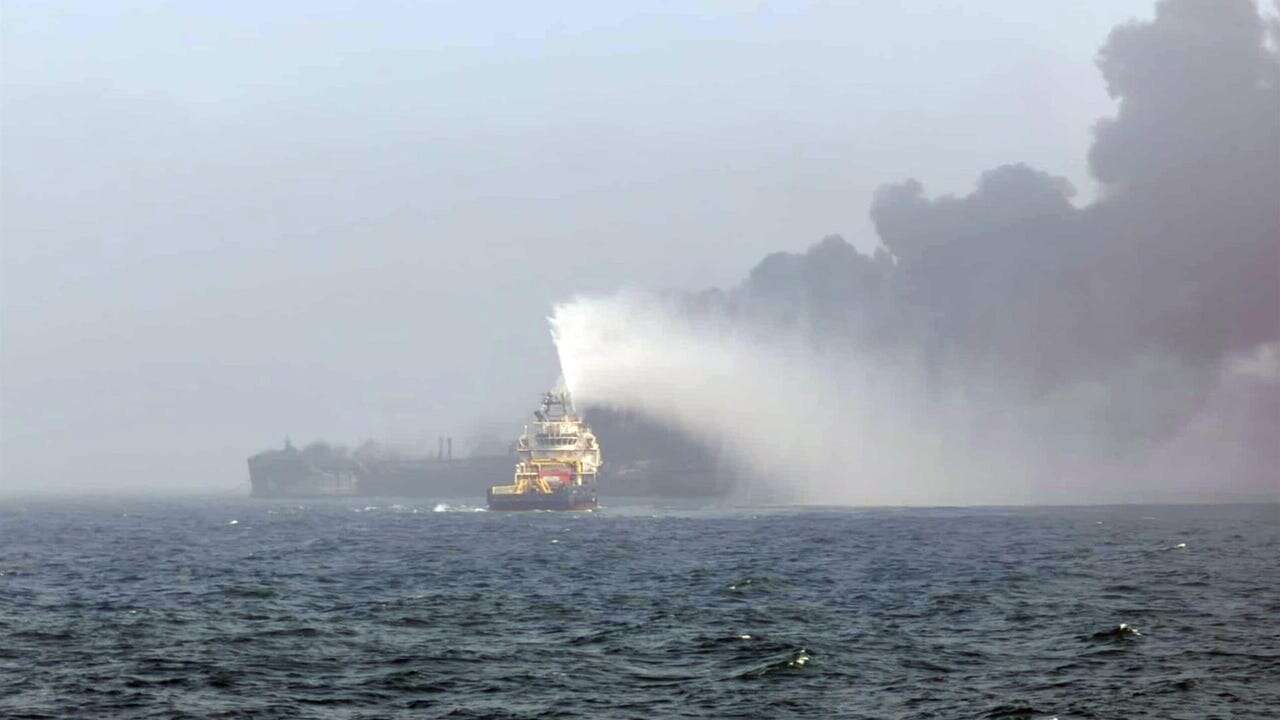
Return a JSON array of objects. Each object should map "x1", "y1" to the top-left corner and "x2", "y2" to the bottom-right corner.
[{"x1": 0, "y1": 500, "x2": 1280, "y2": 720}]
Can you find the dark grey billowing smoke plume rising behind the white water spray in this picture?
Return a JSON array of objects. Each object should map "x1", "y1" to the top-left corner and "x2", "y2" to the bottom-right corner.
[{"x1": 562, "y1": 0, "x2": 1280, "y2": 498}]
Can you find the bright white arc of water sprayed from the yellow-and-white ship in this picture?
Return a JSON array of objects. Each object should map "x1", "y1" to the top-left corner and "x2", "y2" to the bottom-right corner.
[{"x1": 550, "y1": 288, "x2": 1027, "y2": 505}]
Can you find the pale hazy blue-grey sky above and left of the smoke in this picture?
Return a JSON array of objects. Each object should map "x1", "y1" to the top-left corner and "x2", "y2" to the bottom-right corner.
[{"x1": 0, "y1": 0, "x2": 1172, "y2": 491}]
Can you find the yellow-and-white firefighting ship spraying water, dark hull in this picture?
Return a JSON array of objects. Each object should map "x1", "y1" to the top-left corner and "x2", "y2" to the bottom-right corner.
[{"x1": 489, "y1": 392, "x2": 602, "y2": 510}]
